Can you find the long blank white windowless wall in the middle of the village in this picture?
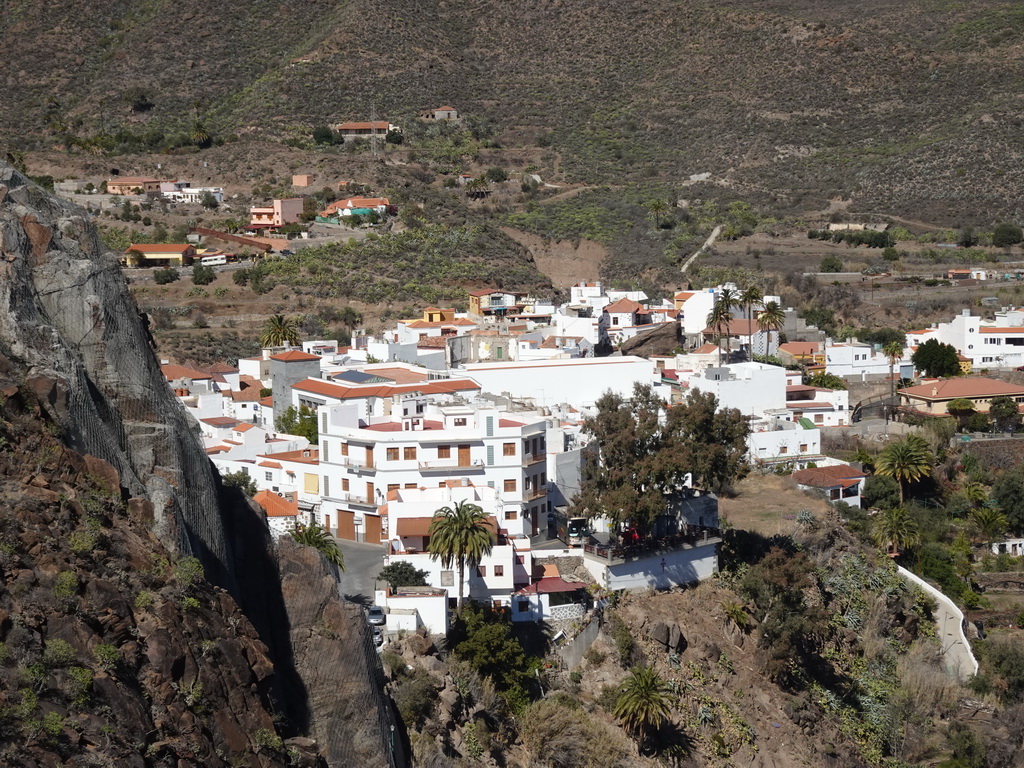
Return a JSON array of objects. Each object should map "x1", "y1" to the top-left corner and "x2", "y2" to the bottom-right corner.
[{"x1": 464, "y1": 356, "x2": 662, "y2": 408}]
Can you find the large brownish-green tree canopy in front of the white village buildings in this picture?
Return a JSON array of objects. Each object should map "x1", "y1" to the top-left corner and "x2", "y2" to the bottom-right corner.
[{"x1": 573, "y1": 384, "x2": 750, "y2": 530}]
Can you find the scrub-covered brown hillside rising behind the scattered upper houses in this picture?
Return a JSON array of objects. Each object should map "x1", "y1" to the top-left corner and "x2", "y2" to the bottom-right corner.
[{"x1": 0, "y1": 0, "x2": 1024, "y2": 222}]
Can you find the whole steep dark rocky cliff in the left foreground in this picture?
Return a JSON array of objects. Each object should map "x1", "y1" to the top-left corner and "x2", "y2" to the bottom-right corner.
[{"x1": 0, "y1": 165, "x2": 387, "y2": 768}]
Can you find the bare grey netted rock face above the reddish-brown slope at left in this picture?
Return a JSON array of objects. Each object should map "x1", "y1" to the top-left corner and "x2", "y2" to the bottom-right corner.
[{"x1": 0, "y1": 165, "x2": 233, "y2": 583}]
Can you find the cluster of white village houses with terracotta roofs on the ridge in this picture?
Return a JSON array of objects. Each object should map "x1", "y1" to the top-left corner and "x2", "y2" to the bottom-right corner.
[{"x1": 153, "y1": 260, "x2": 1024, "y2": 634}]
